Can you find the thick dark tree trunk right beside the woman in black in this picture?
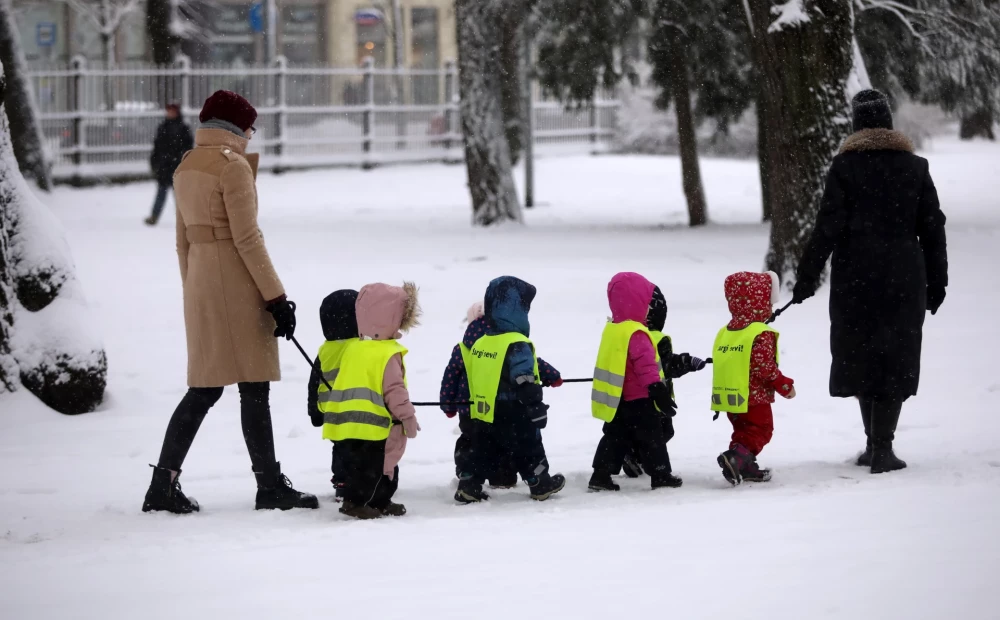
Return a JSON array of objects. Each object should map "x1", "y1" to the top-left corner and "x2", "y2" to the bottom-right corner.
[{"x1": 748, "y1": 0, "x2": 853, "y2": 284}]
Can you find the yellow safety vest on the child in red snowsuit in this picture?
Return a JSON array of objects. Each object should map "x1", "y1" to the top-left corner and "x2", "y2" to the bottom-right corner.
[{"x1": 712, "y1": 323, "x2": 778, "y2": 413}]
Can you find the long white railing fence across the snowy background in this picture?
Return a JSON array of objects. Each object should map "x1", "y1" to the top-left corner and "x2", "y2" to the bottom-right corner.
[{"x1": 29, "y1": 57, "x2": 619, "y2": 178}]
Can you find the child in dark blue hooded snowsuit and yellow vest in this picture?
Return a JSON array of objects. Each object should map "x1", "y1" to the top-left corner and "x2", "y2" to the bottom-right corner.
[{"x1": 455, "y1": 276, "x2": 566, "y2": 504}]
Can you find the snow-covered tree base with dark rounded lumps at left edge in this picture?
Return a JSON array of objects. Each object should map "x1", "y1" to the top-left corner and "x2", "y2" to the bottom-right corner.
[{"x1": 0, "y1": 67, "x2": 108, "y2": 414}]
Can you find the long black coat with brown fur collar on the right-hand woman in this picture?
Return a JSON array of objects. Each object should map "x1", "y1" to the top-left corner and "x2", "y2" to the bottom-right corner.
[{"x1": 798, "y1": 129, "x2": 948, "y2": 400}]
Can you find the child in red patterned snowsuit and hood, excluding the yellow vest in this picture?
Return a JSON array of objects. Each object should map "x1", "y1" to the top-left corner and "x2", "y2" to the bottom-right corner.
[{"x1": 718, "y1": 271, "x2": 795, "y2": 485}]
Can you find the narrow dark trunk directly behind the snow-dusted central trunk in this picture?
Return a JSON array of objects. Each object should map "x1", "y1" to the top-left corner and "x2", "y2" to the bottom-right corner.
[{"x1": 500, "y1": 0, "x2": 528, "y2": 164}]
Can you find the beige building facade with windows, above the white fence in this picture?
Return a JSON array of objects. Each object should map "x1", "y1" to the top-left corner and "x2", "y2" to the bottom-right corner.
[{"x1": 13, "y1": 0, "x2": 458, "y2": 69}]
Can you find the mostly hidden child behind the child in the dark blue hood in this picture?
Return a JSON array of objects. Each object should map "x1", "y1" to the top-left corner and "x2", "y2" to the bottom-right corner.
[{"x1": 440, "y1": 302, "x2": 562, "y2": 489}]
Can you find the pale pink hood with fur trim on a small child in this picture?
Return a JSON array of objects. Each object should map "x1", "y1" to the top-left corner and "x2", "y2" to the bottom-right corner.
[{"x1": 355, "y1": 282, "x2": 421, "y2": 340}]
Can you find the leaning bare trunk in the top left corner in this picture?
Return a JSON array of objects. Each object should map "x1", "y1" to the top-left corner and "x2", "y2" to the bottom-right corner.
[{"x1": 0, "y1": 0, "x2": 52, "y2": 191}]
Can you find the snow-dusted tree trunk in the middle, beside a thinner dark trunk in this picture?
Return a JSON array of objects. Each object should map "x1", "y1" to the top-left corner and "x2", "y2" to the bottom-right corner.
[{"x1": 455, "y1": 0, "x2": 522, "y2": 226}]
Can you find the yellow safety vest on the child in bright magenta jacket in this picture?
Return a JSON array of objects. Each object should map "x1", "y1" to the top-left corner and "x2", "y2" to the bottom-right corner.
[{"x1": 590, "y1": 321, "x2": 663, "y2": 422}]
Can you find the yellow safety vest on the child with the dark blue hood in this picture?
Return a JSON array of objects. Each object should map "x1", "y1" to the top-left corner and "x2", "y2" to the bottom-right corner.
[{"x1": 460, "y1": 332, "x2": 539, "y2": 424}]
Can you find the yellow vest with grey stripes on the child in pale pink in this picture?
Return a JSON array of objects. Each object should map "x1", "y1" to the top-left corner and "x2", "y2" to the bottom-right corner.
[{"x1": 319, "y1": 340, "x2": 407, "y2": 441}]
